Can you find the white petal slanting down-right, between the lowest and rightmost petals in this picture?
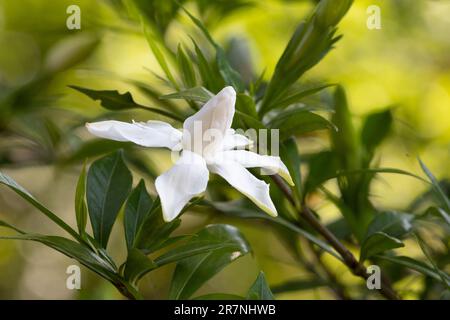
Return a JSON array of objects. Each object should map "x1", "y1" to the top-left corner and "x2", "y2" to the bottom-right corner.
[{"x1": 208, "y1": 162, "x2": 278, "y2": 217}]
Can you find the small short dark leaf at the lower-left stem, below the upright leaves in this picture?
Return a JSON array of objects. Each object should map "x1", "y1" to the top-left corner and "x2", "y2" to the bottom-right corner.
[{"x1": 124, "y1": 248, "x2": 157, "y2": 285}]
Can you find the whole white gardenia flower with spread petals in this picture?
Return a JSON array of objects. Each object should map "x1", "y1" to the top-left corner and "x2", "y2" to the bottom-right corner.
[{"x1": 86, "y1": 87, "x2": 293, "y2": 221}]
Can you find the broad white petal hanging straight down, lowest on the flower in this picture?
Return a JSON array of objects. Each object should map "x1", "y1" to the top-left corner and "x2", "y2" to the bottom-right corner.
[{"x1": 155, "y1": 150, "x2": 209, "y2": 222}]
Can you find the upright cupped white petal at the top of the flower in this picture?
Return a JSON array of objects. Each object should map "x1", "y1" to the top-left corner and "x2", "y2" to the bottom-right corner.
[{"x1": 183, "y1": 87, "x2": 236, "y2": 154}]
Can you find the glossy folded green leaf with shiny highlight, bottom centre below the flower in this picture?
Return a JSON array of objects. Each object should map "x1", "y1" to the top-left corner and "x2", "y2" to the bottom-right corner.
[{"x1": 169, "y1": 224, "x2": 250, "y2": 299}]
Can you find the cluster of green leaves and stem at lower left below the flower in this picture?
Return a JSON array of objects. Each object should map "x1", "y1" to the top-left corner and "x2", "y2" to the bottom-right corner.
[{"x1": 0, "y1": 152, "x2": 256, "y2": 299}]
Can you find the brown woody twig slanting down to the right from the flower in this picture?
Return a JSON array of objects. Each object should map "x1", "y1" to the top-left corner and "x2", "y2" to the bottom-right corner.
[{"x1": 271, "y1": 175, "x2": 401, "y2": 300}]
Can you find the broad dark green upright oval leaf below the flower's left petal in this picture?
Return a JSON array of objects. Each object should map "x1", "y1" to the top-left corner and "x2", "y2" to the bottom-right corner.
[{"x1": 87, "y1": 151, "x2": 132, "y2": 248}]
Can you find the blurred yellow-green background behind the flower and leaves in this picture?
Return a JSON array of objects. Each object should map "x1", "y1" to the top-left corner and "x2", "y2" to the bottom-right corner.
[{"x1": 0, "y1": 0, "x2": 450, "y2": 299}]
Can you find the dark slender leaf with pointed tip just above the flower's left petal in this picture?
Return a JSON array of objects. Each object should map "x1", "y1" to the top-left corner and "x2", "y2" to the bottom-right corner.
[{"x1": 69, "y1": 86, "x2": 183, "y2": 122}]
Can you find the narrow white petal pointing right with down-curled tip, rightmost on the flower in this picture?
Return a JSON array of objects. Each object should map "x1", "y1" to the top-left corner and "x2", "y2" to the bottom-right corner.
[{"x1": 215, "y1": 150, "x2": 294, "y2": 186}]
